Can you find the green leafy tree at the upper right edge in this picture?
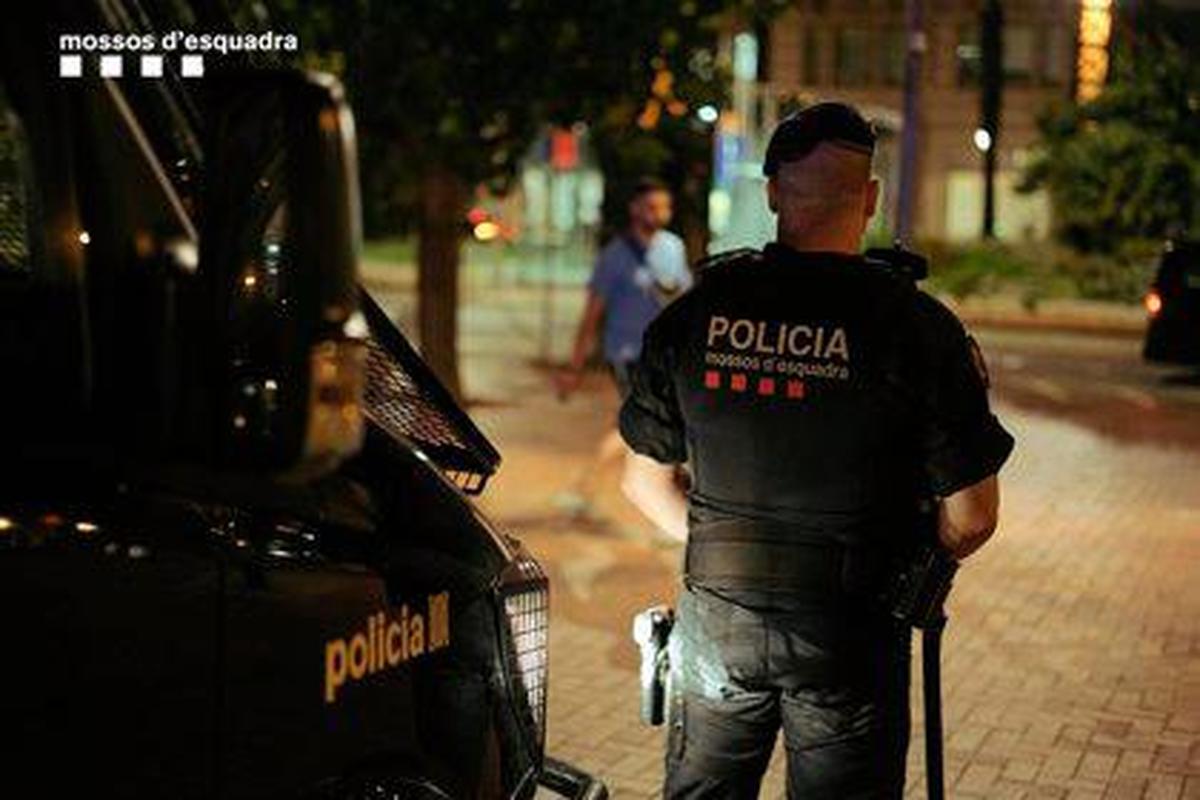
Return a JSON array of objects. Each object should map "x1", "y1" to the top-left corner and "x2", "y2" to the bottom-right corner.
[{"x1": 1024, "y1": 6, "x2": 1200, "y2": 253}]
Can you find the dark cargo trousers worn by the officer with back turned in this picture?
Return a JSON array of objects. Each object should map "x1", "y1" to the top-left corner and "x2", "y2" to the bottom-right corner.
[{"x1": 664, "y1": 588, "x2": 911, "y2": 800}]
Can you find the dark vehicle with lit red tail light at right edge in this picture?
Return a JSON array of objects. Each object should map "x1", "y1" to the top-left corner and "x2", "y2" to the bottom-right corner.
[{"x1": 1144, "y1": 240, "x2": 1200, "y2": 366}]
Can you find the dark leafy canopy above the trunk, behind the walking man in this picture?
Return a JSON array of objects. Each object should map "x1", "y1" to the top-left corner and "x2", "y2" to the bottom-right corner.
[{"x1": 343, "y1": 0, "x2": 785, "y2": 234}]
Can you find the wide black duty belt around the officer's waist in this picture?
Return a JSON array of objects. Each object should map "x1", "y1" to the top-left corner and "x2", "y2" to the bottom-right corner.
[{"x1": 684, "y1": 523, "x2": 889, "y2": 600}]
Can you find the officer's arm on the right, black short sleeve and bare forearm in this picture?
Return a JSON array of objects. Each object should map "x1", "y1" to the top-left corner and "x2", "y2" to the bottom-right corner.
[{"x1": 918, "y1": 295, "x2": 1014, "y2": 559}]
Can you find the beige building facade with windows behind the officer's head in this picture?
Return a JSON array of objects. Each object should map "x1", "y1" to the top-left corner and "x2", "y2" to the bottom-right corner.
[{"x1": 756, "y1": 0, "x2": 1079, "y2": 241}]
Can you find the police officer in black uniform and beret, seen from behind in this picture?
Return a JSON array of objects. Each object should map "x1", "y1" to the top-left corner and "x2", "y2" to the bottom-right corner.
[{"x1": 620, "y1": 103, "x2": 1013, "y2": 800}]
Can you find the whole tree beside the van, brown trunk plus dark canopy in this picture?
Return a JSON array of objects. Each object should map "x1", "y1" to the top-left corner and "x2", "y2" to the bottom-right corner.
[{"x1": 260, "y1": 0, "x2": 787, "y2": 390}]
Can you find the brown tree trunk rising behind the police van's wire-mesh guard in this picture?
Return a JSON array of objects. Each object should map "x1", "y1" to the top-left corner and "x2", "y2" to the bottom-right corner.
[{"x1": 416, "y1": 167, "x2": 468, "y2": 399}]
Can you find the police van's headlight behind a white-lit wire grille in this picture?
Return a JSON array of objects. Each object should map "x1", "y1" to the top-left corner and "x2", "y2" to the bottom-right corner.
[{"x1": 500, "y1": 555, "x2": 550, "y2": 751}]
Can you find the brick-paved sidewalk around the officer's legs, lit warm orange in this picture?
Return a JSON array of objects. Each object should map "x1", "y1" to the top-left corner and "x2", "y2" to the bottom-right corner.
[{"x1": 476, "y1": 357, "x2": 1200, "y2": 800}]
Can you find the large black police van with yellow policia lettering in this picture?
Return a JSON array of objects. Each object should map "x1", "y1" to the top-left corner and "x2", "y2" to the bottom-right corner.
[{"x1": 0, "y1": 0, "x2": 605, "y2": 799}]
